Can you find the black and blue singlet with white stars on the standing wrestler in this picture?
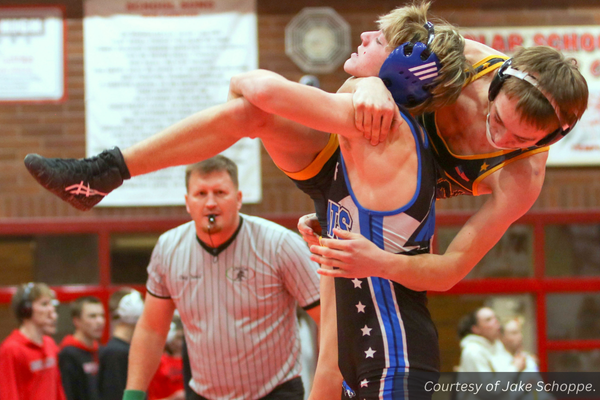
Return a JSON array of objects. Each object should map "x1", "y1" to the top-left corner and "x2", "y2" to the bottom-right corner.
[{"x1": 290, "y1": 110, "x2": 439, "y2": 399}]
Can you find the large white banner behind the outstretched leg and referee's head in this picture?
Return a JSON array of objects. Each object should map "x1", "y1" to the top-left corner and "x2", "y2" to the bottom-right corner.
[{"x1": 83, "y1": 0, "x2": 261, "y2": 206}]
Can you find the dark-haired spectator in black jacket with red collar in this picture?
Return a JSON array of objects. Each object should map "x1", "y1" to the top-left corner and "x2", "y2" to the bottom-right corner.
[{"x1": 58, "y1": 296, "x2": 106, "y2": 400}]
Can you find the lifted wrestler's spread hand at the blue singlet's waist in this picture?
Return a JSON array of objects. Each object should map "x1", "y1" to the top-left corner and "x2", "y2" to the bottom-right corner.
[{"x1": 310, "y1": 228, "x2": 384, "y2": 278}]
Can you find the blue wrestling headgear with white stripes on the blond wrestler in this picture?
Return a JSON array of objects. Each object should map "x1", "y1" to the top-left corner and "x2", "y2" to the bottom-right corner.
[{"x1": 379, "y1": 22, "x2": 441, "y2": 107}]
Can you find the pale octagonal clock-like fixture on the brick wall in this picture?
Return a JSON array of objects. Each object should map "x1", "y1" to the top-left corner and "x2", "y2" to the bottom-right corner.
[{"x1": 285, "y1": 7, "x2": 351, "y2": 74}]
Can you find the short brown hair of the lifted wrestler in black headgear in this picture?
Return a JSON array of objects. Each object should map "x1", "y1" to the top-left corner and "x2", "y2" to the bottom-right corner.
[{"x1": 501, "y1": 46, "x2": 589, "y2": 131}]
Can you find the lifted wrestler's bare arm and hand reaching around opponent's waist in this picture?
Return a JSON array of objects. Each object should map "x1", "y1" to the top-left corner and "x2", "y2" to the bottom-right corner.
[{"x1": 311, "y1": 153, "x2": 547, "y2": 291}]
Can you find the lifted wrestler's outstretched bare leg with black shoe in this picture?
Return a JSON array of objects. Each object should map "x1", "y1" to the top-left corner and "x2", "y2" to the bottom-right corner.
[{"x1": 25, "y1": 98, "x2": 329, "y2": 211}]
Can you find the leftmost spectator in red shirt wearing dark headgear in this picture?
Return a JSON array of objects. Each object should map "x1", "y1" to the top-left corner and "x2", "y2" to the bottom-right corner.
[{"x1": 0, "y1": 283, "x2": 65, "y2": 400}]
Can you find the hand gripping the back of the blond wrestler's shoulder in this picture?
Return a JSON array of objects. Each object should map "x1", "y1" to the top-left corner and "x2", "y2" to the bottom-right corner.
[{"x1": 352, "y1": 77, "x2": 404, "y2": 145}]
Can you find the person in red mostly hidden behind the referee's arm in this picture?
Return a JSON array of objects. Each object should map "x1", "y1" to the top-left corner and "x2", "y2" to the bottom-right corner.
[{"x1": 148, "y1": 313, "x2": 185, "y2": 400}]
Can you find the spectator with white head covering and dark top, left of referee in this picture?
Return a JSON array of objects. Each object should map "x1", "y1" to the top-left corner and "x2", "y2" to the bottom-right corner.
[{"x1": 98, "y1": 288, "x2": 144, "y2": 400}]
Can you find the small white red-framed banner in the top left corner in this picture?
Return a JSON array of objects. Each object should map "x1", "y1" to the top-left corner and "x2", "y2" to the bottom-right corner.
[{"x1": 0, "y1": 6, "x2": 65, "y2": 103}]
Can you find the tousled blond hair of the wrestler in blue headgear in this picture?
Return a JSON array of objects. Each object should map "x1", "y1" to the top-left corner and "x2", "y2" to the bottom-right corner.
[{"x1": 377, "y1": 0, "x2": 473, "y2": 115}]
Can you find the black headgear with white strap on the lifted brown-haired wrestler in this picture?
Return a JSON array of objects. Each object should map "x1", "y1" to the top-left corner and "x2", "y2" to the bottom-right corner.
[{"x1": 488, "y1": 58, "x2": 575, "y2": 147}]
